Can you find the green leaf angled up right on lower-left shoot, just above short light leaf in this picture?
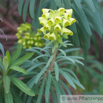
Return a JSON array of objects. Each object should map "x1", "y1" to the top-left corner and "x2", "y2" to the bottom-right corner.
[{"x1": 13, "y1": 53, "x2": 34, "y2": 66}]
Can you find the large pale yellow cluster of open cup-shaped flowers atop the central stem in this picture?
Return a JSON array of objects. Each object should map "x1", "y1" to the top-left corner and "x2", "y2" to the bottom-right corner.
[{"x1": 39, "y1": 8, "x2": 76, "y2": 43}]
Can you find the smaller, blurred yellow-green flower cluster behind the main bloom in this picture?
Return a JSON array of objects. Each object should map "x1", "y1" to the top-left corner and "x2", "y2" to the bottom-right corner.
[{"x1": 16, "y1": 23, "x2": 44, "y2": 49}]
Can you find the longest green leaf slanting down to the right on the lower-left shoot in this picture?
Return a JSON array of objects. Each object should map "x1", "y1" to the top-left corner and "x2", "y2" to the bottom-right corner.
[{"x1": 11, "y1": 77, "x2": 35, "y2": 96}]
